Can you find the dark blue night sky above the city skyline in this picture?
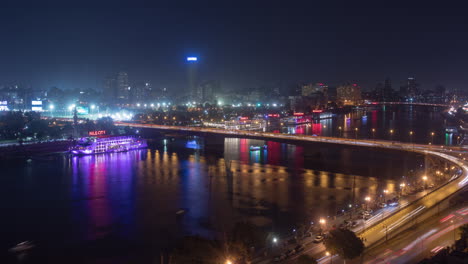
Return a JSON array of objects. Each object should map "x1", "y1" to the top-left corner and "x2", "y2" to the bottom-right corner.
[{"x1": 0, "y1": 1, "x2": 468, "y2": 91}]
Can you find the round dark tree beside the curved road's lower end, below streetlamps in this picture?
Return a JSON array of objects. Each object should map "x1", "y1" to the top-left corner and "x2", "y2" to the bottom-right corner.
[{"x1": 324, "y1": 229, "x2": 364, "y2": 259}]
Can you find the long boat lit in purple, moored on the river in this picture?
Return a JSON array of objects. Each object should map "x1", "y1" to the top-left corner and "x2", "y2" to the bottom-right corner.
[{"x1": 70, "y1": 136, "x2": 148, "y2": 155}]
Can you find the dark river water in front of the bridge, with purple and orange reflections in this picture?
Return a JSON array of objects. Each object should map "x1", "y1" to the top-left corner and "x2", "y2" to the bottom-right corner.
[{"x1": 0, "y1": 105, "x2": 440, "y2": 263}]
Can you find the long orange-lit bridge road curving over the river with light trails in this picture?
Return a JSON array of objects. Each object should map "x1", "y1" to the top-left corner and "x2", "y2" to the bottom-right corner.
[{"x1": 116, "y1": 122, "x2": 468, "y2": 263}]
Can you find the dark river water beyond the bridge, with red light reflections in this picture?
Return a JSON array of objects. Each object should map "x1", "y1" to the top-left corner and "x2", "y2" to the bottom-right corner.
[{"x1": 269, "y1": 105, "x2": 458, "y2": 145}]
